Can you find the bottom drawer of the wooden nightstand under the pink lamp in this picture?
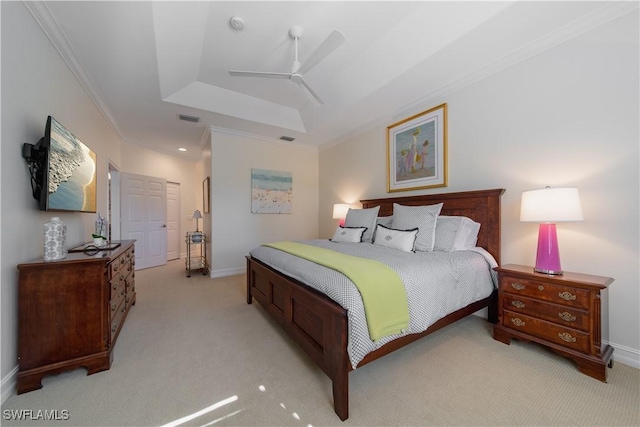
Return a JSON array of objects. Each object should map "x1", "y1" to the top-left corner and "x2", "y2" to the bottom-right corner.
[{"x1": 502, "y1": 310, "x2": 589, "y2": 353}]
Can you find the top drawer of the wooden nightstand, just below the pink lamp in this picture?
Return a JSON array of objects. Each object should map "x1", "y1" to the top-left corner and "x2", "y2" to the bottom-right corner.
[{"x1": 500, "y1": 276, "x2": 589, "y2": 310}]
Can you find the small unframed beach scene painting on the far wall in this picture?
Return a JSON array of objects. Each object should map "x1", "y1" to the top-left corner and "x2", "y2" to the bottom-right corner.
[{"x1": 251, "y1": 169, "x2": 293, "y2": 214}]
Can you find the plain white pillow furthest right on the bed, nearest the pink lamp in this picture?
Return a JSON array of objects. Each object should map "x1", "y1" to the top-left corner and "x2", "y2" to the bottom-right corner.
[{"x1": 433, "y1": 215, "x2": 480, "y2": 252}]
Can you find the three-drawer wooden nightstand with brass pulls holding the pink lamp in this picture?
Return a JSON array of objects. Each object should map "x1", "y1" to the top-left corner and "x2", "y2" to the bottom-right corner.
[{"x1": 493, "y1": 264, "x2": 613, "y2": 382}]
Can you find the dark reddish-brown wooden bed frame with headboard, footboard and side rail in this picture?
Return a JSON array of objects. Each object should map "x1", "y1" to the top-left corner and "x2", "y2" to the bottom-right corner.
[{"x1": 246, "y1": 189, "x2": 504, "y2": 421}]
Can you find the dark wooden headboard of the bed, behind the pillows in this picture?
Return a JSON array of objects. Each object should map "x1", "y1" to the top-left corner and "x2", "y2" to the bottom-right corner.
[{"x1": 360, "y1": 188, "x2": 504, "y2": 264}]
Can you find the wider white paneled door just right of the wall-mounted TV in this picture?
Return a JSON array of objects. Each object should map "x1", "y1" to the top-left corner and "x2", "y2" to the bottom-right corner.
[{"x1": 120, "y1": 173, "x2": 167, "y2": 270}]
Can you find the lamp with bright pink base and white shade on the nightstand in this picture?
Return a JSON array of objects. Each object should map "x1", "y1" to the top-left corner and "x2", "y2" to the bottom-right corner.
[{"x1": 520, "y1": 187, "x2": 584, "y2": 275}]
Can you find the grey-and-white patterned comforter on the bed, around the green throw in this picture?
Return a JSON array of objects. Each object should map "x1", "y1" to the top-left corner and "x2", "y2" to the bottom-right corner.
[{"x1": 251, "y1": 240, "x2": 496, "y2": 369}]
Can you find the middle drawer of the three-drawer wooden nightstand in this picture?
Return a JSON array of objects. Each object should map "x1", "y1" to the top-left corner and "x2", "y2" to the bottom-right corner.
[{"x1": 502, "y1": 293, "x2": 589, "y2": 331}]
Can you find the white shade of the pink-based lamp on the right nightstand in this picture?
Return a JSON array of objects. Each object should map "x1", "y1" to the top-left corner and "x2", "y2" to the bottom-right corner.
[{"x1": 520, "y1": 187, "x2": 584, "y2": 223}]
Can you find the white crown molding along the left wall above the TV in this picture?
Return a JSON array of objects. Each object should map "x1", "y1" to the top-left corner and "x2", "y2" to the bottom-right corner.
[{"x1": 24, "y1": 1, "x2": 124, "y2": 140}]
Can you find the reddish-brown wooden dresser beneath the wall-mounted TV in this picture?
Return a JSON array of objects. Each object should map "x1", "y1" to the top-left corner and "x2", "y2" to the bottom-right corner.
[{"x1": 17, "y1": 240, "x2": 136, "y2": 394}]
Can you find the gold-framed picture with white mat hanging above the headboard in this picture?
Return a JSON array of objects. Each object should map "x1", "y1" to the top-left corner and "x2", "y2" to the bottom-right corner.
[{"x1": 387, "y1": 104, "x2": 447, "y2": 193}]
